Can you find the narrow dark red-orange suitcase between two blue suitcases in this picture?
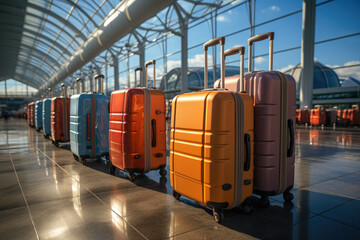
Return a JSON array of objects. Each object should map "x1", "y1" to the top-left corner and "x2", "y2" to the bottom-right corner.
[{"x1": 51, "y1": 83, "x2": 70, "y2": 147}]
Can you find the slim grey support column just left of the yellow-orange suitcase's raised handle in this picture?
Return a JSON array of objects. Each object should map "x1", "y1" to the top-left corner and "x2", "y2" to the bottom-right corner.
[{"x1": 181, "y1": 23, "x2": 188, "y2": 93}]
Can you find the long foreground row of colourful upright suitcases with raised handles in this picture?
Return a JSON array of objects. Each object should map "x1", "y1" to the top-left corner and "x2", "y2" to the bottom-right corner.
[{"x1": 29, "y1": 32, "x2": 296, "y2": 222}]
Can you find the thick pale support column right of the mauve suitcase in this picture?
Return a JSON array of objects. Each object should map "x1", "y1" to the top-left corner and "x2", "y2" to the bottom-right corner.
[{"x1": 300, "y1": 0, "x2": 316, "y2": 108}]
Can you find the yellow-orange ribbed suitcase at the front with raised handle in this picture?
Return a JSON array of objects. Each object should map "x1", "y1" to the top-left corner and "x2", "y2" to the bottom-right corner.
[{"x1": 170, "y1": 37, "x2": 254, "y2": 222}]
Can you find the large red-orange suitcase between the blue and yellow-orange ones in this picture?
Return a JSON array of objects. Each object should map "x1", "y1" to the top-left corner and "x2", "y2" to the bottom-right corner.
[{"x1": 108, "y1": 60, "x2": 167, "y2": 181}]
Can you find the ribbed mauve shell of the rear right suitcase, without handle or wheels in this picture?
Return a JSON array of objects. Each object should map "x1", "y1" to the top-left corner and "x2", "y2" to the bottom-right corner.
[{"x1": 214, "y1": 71, "x2": 296, "y2": 195}]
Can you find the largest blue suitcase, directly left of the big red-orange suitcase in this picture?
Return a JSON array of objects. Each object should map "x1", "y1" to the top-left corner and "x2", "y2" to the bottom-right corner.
[{"x1": 70, "y1": 75, "x2": 109, "y2": 163}]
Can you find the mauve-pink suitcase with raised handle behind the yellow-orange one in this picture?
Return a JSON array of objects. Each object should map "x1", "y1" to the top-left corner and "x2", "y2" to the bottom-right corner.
[{"x1": 214, "y1": 32, "x2": 296, "y2": 207}]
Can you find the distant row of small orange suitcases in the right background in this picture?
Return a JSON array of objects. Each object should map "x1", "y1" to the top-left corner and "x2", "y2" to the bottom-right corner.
[{"x1": 296, "y1": 105, "x2": 360, "y2": 126}]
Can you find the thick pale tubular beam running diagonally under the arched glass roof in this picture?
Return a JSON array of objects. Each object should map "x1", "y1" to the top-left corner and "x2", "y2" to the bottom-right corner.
[{"x1": 42, "y1": 0, "x2": 173, "y2": 89}]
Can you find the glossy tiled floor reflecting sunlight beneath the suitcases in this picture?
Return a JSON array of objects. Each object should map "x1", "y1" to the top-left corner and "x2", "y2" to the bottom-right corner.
[{"x1": 0, "y1": 119, "x2": 360, "y2": 239}]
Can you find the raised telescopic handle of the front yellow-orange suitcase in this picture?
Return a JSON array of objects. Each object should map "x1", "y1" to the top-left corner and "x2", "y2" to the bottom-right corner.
[{"x1": 204, "y1": 37, "x2": 225, "y2": 89}]
